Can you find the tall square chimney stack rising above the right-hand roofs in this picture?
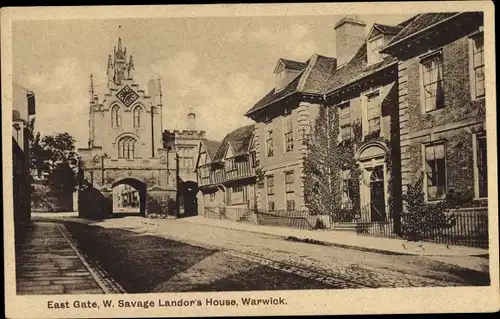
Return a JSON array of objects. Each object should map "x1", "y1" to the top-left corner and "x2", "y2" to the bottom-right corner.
[{"x1": 334, "y1": 16, "x2": 366, "y2": 66}]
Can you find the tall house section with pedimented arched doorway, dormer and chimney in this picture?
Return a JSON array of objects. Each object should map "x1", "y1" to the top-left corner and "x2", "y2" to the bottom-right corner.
[{"x1": 325, "y1": 17, "x2": 412, "y2": 227}]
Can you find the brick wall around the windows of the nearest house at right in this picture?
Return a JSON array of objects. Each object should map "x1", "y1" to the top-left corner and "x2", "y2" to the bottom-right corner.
[{"x1": 398, "y1": 24, "x2": 485, "y2": 208}]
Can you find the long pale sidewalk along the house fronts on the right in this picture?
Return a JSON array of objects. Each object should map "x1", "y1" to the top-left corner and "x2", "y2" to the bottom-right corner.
[{"x1": 177, "y1": 216, "x2": 489, "y2": 256}]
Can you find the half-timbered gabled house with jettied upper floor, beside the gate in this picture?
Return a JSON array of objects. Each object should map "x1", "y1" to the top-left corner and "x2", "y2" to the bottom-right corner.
[{"x1": 196, "y1": 125, "x2": 256, "y2": 219}]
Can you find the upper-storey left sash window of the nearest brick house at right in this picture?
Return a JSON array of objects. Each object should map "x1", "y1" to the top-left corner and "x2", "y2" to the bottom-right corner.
[{"x1": 421, "y1": 53, "x2": 444, "y2": 112}]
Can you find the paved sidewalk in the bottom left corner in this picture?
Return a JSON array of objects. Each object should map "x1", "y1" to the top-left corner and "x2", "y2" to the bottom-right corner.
[{"x1": 16, "y1": 222, "x2": 105, "y2": 295}]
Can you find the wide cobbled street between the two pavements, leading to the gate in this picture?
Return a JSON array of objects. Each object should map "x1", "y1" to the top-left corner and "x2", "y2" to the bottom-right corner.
[{"x1": 34, "y1": 217, "x2": 489, "y2": 292}]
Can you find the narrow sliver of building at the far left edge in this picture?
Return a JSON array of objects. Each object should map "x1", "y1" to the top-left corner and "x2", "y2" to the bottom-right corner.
[{"x1": 12, "y1": 83, "x2": 35, "y2": 238}]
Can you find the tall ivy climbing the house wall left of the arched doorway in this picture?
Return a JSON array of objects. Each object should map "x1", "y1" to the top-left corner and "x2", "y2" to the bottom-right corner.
[{"x1": 304, "y1": 106, "x2": 342, "y2": 217}]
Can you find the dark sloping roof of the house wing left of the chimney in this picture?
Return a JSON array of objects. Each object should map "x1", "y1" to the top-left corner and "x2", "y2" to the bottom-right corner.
[{"x1": 245, "y1": 54, "x2": 337, "y2": 116}]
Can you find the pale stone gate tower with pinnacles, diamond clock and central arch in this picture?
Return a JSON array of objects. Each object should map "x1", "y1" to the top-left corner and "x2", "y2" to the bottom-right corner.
[{"x1": 78, "y1": 39, "x2": 177, "y2": 219}]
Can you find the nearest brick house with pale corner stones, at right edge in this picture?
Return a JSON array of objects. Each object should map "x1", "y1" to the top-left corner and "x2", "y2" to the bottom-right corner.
[{"x1": 382, "y1": 12, "x2": 488, "y2": 207}]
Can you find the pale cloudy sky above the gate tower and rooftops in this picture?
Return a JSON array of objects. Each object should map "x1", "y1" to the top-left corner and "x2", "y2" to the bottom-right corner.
[{"x1": 12, "y1": 15, "x2": 410, "y2": 147}]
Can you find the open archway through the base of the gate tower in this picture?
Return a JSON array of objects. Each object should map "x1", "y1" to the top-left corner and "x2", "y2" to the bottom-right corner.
[{"x1": 112, "y1": 178, "x2": 147, "y2": 216}]
